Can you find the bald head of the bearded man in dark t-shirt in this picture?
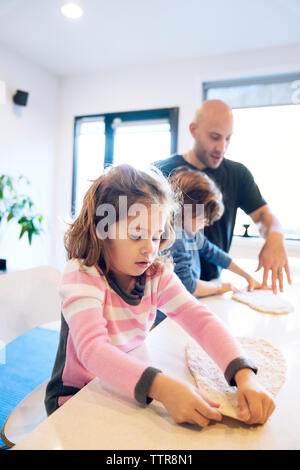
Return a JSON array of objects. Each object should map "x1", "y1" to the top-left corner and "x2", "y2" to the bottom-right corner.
[{"x1": 187, "y1": 100, "x2": 233, "y2": 169}]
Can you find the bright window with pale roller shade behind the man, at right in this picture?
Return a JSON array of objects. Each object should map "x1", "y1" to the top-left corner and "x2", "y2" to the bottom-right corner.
[{"x1": 203, "y1": 75, "x2": 300, "y2": 239}]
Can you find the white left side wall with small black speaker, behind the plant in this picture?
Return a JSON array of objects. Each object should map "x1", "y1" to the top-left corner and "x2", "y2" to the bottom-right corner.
[{"x1": 0, "y1": 45, "x2": 58, "y2": 269}]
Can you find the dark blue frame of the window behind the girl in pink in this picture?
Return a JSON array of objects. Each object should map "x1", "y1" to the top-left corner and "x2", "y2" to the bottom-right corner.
[{"x1": 71, "y1": 107, "x2": 179, "y2": 216}]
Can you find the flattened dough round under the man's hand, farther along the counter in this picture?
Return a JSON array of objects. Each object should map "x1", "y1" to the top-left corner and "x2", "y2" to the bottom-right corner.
[{"x1": 232, "y1": 289, "x2": 294, "y2": 315}]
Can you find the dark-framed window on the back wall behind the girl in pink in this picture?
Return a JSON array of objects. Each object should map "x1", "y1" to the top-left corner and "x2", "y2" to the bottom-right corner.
[{"x1": 72, "y1": 108, "x2": 178, "y2": 215}]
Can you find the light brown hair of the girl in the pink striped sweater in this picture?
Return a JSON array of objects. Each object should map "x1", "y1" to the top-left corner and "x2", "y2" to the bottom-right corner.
[{"x1": 64, "y1": 164, "x2": 180, "y2": 274}]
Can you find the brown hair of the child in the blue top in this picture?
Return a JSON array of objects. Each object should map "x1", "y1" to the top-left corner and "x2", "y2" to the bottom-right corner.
[{"x1": 170, "y1": 166, "x2": 224, "y2": 225}]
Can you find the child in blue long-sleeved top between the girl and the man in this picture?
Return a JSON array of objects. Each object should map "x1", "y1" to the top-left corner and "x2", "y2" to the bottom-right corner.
[{"x1": 170, "y1": 167, "x2": 261, "y2": 297}]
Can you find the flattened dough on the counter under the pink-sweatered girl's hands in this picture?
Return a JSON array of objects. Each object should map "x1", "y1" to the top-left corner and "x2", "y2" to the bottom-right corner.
[{"x1": 185, "y1": 337, "x2": 286, "y2": 419}]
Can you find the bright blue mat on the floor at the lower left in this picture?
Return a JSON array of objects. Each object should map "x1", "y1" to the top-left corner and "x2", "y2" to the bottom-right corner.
[{"x1": 0, "y1": 328, "x2": 59, "y2": 445}]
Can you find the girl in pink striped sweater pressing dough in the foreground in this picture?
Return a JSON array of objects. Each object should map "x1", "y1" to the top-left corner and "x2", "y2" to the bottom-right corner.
[{"x1": 45, "y1": 165, "x2": 274, "y2": 427}]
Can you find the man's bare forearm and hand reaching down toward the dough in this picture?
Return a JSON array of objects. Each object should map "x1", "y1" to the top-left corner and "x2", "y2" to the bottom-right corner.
[{"x1": 249, "y1": 204, "x2": 292, "y2": 294}]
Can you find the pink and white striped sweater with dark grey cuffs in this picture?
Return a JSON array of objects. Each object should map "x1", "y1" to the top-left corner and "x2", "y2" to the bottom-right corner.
[{"x1": 45, "y1": 259, "x2": 255, "y2": 414}]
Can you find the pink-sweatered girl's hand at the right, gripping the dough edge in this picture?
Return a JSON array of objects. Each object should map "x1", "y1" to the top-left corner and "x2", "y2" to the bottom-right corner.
[{"x1": 234, "y1": 369, "x2": 275, "y2": 424}]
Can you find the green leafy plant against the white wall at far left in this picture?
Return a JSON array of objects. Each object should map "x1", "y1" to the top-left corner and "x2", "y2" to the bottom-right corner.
[{"x1": 0, "y1": 175, "x2": 43, "y2": 271}]
